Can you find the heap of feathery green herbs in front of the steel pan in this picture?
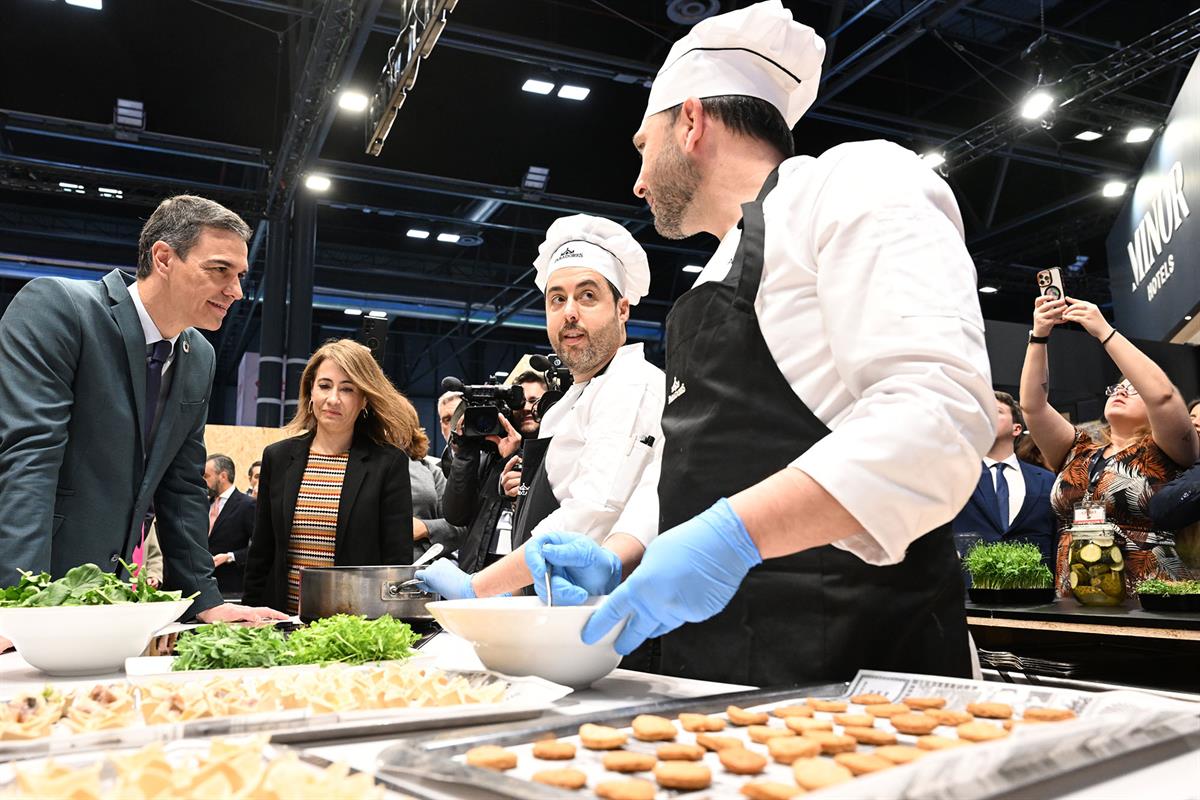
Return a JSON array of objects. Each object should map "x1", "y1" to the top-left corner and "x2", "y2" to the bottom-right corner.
[{"x1": 172, "y1": 614, "x2": 420, "y2": 672}]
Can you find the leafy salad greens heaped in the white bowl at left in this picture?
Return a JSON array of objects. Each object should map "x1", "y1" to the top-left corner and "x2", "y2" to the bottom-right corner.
[{"x1": 0, "y1": 561, "x2": 196, "y2": 608}]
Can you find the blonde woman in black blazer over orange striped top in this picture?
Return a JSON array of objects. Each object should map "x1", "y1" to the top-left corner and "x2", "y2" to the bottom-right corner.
[{"x1": 242, "y1": 339, "x2": 425, "y2": 614}]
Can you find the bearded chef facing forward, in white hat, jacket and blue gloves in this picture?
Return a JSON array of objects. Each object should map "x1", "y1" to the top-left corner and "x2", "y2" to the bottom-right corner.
[{"x1": 416, "y1": 215, "x2": 666, "y2": 602}]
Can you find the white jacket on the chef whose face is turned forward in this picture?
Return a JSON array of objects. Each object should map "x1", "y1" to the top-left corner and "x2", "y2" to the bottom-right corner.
[{"x1": 530, "y1": 374, "x2": 664, "y2": 545}]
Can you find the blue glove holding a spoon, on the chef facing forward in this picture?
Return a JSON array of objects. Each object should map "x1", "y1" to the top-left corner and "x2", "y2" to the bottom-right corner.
[{"x1": 524, "y1": 531, "x2": 620, "y2": 606}]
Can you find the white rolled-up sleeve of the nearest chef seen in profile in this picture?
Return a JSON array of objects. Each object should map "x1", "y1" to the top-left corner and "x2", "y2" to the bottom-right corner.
[{"x1": 791, "y1": 143, "x2": 995, "y2": 565}]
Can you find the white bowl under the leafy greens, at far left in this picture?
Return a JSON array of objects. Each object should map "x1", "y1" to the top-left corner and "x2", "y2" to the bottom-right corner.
[{"x1": 0, "y1": 600, "x2": 192, "y2": 675}]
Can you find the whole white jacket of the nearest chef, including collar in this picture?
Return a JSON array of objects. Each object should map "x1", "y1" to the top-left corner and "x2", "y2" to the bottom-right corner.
[{"x1": 696, "y1": 140, "x2": 996, "y2": 565}]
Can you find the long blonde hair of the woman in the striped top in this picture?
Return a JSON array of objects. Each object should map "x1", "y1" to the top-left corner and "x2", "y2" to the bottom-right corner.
[{"x1": 287, "y1": 339, "x2": 430, "y2": 458}]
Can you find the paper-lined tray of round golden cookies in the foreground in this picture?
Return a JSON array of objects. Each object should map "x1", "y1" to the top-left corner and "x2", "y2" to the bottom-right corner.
[{"x1": 378, "y1": 672, "x2": 1200, "y2": 800}]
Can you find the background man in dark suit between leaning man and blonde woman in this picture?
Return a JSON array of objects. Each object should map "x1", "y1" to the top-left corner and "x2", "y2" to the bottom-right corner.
[{"x1": 204, "y1": 453, "x2": 254, "y2": 597}]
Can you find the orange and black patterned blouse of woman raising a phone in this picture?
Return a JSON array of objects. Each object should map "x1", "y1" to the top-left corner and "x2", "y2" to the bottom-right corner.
[{"x1": 1050, "y1": 431, "x2": 1183, "y2": 596}]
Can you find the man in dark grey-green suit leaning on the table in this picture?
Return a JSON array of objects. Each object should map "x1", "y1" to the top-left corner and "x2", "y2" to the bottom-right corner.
[{"x1": 0, "y1": 196, "x2": 282, "y2": 645}]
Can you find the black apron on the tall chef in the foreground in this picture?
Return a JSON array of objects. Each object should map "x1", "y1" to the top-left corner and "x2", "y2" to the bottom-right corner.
[{"x1": 658, "y1": 165, "x2": 971, "y2": 686}]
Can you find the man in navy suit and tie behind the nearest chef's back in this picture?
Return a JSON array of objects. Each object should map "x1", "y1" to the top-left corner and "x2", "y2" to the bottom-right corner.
[{"x1": 953, "y1": 392, "x2": 1057, "y2": 571}]
